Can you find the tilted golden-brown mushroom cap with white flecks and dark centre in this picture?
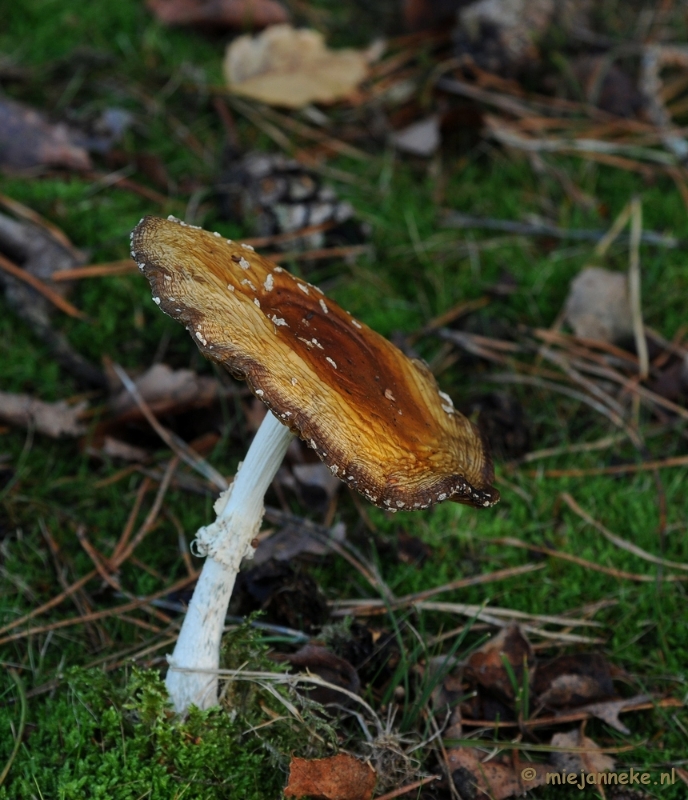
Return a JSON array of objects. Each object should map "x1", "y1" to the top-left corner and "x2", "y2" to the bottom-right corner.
[{"x1": 132, "y1": 217, "x2": 499, "y2": 510}]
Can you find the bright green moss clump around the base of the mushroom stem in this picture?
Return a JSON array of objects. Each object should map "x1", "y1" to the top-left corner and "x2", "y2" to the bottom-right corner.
[{"x1": 0, "y1": 629, "x2": 332, "y2": 800}]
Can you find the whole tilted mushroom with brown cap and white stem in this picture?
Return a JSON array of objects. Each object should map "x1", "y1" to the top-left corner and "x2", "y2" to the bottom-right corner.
[{"x1": 132, "y1": 217, "x2": 499, "y2": 711}]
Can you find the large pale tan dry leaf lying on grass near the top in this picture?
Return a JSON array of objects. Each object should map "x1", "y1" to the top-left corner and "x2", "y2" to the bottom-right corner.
[{"x1": 224, "y1": 25, "x2": 368, "y2": 108}]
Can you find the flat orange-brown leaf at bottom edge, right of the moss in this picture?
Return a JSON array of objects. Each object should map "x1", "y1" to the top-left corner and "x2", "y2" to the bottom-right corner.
[{"x1": 284, "y1": 753, "x2": 376, "y2": 800}]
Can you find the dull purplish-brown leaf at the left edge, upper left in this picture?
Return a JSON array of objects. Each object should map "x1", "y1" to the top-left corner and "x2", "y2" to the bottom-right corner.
[{"x1": 0, "y1": 97, "x2": 91, "y2": 170}]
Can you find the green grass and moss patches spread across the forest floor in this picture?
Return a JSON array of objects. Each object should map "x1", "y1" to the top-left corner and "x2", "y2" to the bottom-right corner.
[{"x1": 0, "y1": 0, "x2": 688, "y2": 800}]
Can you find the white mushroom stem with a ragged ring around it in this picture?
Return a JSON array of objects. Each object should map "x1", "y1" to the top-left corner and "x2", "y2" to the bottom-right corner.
[{"x1": 166, "y1": 412, "x2": 294, "y2": 712}]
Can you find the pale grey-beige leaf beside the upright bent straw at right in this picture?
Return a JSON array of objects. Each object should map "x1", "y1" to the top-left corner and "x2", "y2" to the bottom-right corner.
[{"x1": 565, "y1": 267, "x2": 633, "y2": 342}]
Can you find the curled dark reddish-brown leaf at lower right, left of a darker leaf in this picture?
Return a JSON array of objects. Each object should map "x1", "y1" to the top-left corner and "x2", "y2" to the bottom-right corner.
[{"x1": 464, "y1": 625, "x2": 535, "y2": 700}]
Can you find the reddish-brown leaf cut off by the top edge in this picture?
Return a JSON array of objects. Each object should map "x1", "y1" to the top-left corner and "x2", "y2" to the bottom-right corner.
[{"x1": 146, "y1": 0, "x2": 289, "y2": 29}]
